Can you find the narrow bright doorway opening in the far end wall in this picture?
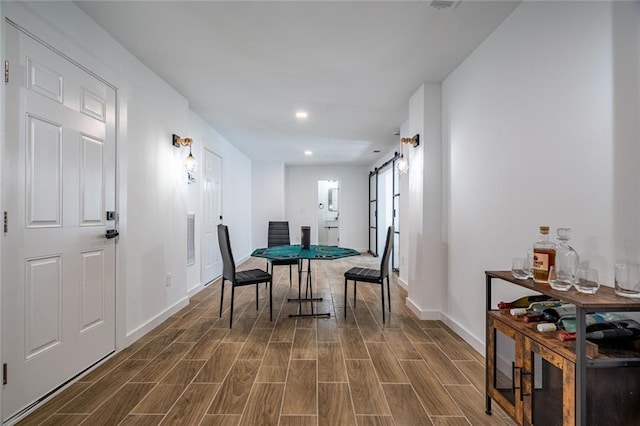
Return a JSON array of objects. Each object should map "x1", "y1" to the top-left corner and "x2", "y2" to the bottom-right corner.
[{"x1": 317, "y1": 180, "x2": 340, "y2": 246}]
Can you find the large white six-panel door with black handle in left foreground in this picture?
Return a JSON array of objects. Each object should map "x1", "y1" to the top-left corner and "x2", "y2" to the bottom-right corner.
[{"x1": 2, "y1": 25, "x2": 116, "y2": 420}]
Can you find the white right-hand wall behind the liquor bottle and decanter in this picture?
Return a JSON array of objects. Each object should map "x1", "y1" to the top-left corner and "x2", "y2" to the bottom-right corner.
[{"x1": 443, "y1": 2, "x2": 620, "y2": 347}]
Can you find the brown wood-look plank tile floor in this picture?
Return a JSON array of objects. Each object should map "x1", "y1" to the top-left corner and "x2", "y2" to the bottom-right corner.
[{"x1": 19, "y1": 256, "x2": 513, "y2": 426}]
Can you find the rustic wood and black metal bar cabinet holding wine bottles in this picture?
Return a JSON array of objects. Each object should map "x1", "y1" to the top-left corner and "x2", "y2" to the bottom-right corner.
[{"x1": 485, "y1": 271, "x2": 640, "y2": 426}]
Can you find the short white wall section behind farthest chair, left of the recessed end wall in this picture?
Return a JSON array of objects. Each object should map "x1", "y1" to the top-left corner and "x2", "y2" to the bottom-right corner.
[{"x1": 251, "y1": 161, "x2": 287, "y2": 249}]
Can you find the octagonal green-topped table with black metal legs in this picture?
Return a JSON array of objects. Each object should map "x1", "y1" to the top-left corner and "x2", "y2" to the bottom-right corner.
[{"x1": 251, "y1": 244, "x2": 360, "y2": 318}]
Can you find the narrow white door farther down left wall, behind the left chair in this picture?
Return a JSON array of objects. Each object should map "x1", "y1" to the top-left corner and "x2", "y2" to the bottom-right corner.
[{"x1": 201, "y1": 148, "x2": 222, "y2": 284}]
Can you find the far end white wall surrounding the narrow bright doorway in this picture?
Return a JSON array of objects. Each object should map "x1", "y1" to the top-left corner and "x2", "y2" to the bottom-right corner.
[{"x1": 285, "y1": 166, "x2": 369, "y2": 251}]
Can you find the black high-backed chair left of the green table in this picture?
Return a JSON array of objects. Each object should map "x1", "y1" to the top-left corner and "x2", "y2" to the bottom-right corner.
[{"x1": 218, "y1": 225, "x2": 273, "y2": 328}]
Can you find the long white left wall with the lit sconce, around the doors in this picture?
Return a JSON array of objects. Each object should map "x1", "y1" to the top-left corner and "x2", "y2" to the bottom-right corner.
[{"x1": 2, "y1": 2, "x2": 252, "y2": 347}]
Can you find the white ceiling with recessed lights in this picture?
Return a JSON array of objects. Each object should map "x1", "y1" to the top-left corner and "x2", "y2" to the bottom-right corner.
[{"x1": 76, "y1": 0, "x2": 519, "y2": 165}]
